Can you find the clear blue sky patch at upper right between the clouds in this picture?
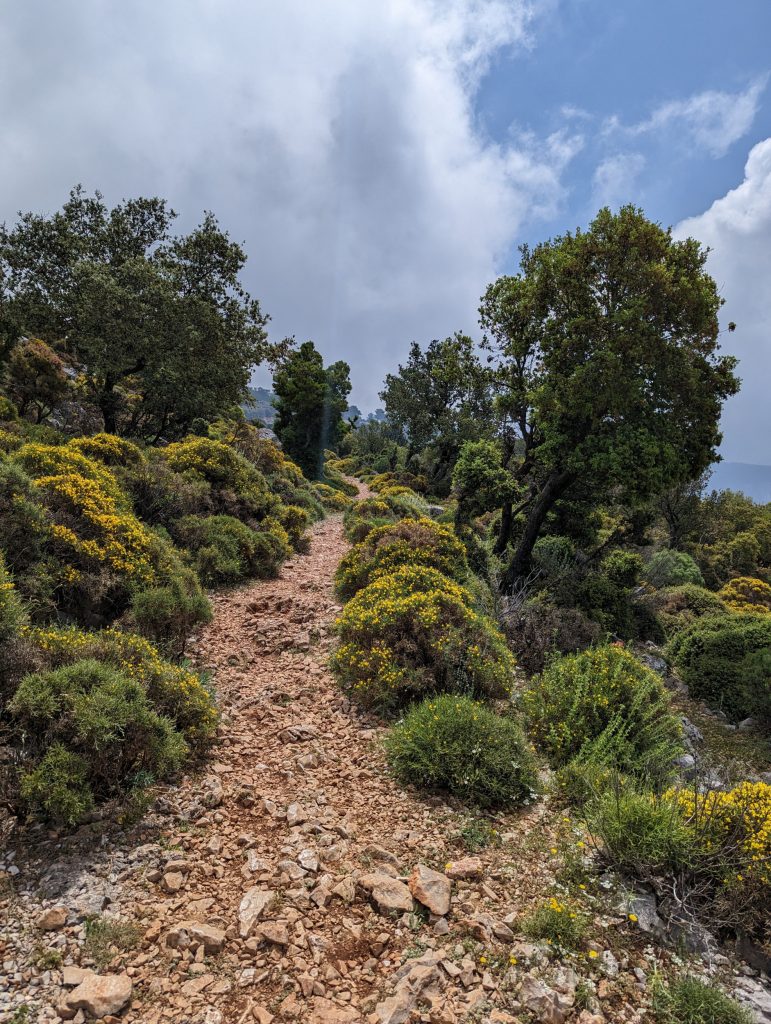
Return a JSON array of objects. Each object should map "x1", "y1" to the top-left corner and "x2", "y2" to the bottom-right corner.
[{"x1": 474, "y1": 0, "x2": 771, "y2": 242}]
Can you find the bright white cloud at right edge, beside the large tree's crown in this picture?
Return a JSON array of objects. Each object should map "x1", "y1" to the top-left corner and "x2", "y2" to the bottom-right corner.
[{"x1": 675, "y1": 138, "x2": 771, "y2": 465}]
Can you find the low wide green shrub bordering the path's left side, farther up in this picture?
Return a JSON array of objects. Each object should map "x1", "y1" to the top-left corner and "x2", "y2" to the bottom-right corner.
[{"x1": 174, "y1": 515, "x2": 290, "y2": 587}]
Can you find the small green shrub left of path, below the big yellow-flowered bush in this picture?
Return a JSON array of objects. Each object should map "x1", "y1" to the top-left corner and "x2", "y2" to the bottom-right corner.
[{"x1": 131, "y1": 569, "x2": 212, "y2": 656}]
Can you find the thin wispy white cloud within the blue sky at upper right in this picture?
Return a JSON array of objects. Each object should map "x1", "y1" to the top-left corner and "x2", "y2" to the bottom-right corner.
[{"x1": 605, "y1": 75, "x2": 768, "y2": 157}]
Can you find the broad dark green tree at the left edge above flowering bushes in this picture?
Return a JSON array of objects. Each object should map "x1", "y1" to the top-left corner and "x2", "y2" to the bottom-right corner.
[{"x1": 0, "y1": 186, "x2": 272, "y2": 437}]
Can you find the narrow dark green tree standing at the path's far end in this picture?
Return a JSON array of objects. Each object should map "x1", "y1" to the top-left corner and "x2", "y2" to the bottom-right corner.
[{"x1": 273, "y1": 341, "x2": 351, "y2": 479}]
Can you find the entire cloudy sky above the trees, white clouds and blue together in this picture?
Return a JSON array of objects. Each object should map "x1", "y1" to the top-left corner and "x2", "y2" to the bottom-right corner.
[{"x1": 0, "y1": 0, "x2": 771, "y2": 463}]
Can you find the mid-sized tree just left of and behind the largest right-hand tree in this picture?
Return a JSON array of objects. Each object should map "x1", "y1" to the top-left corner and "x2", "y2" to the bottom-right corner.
[{"x1": 380, "y1": 334, "x2": 492, "y2": 492}]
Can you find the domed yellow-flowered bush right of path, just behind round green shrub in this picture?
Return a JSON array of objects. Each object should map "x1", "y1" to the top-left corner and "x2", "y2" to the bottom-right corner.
[{"x1": 333, "y1": 566, "x2": 514, "y2": 706}]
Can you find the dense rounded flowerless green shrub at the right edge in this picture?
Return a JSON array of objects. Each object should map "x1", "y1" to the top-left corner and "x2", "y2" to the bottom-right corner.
[{"x1": 666, "y1": 613, "x2": 771, "y2": 721}]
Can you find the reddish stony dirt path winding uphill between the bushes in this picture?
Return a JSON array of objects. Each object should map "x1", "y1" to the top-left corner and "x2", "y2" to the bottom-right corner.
[{"x1": 0, "y1": 495, "x2": 581, "y2": 1024}]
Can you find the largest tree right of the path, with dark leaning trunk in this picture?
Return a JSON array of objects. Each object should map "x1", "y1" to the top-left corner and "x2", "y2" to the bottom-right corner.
[{"x1": 480, "y1": 206, "x2": 738, "y2": 589}]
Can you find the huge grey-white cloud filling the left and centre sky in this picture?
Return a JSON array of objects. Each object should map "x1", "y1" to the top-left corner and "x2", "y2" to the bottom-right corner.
[{"x1": 0, "y1": 0, "x2": 580, "y2": 406}]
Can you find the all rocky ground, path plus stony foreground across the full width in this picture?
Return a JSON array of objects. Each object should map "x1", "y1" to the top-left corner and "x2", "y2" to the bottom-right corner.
[{"x1": 0, "y1": 489, "x2": 771, "y2": 1024}]
